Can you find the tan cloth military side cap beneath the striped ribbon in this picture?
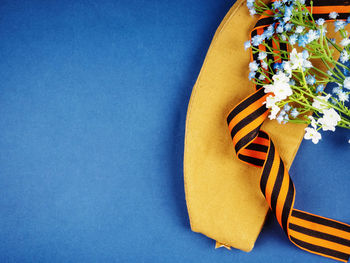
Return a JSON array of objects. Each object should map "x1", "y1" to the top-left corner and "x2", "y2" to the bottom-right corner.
[{"x1": 184, "y1": 0, "x2": 304, "y2": 251}]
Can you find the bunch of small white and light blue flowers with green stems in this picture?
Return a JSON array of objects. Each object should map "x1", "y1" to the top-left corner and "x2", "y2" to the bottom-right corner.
[{"x1": 245, "y1": 0, "x2": 350, "y2": 143}]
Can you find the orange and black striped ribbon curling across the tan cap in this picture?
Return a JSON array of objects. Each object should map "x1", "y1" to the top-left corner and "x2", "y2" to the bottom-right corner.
[{"x1": 227, "y1": 0, "x2": 350, "y2": 262}]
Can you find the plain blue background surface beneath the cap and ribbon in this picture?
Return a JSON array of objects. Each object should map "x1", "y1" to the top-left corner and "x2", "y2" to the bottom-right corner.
[{"x1": 0, "y1": 0, "x2": 350, "y2": 263}]
